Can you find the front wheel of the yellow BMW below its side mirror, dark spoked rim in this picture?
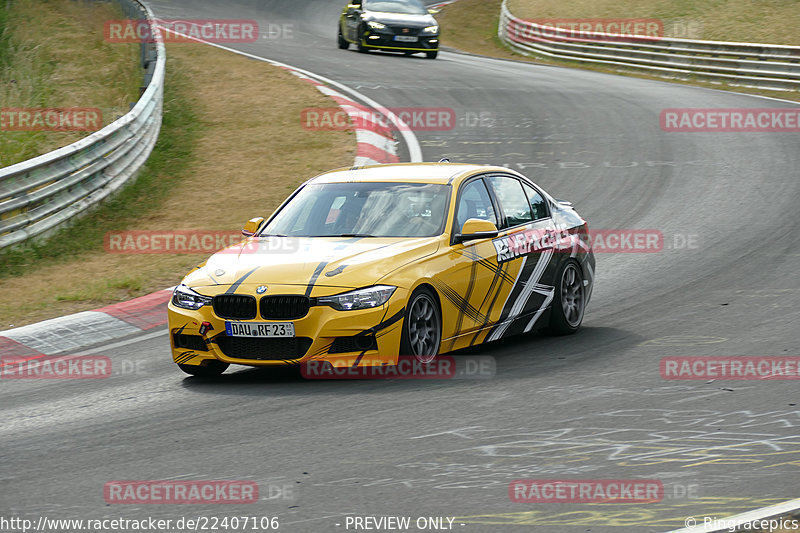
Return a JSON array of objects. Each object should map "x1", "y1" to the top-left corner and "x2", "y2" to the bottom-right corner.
[{"x1": 400, "y1": 288, "x2": 442, "y2": 363}]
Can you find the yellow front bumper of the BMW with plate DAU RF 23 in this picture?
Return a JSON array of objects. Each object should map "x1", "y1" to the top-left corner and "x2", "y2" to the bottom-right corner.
[{"x1": 168, "y1": 285, "x2": 408, "y2": 367}]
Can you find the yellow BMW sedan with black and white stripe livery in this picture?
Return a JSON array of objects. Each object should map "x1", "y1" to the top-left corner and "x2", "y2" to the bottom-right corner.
[{"x1": 169, "y1": 163, "x2": 595, "y2": 376}]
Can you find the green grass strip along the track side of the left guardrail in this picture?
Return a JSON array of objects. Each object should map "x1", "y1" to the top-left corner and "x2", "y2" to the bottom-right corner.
[{"x1": 0, "y1": 63, "x2": 199, "y2": 278}]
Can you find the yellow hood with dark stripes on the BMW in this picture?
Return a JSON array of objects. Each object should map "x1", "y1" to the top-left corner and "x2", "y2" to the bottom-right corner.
[{"x1": 183, "y1": 237, "x2": 439, "y2": 288}]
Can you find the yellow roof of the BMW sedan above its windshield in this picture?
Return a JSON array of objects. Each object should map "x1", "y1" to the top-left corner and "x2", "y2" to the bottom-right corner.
[{"x1": 309, "y1": 163, "x2": 508, "y2": 184}]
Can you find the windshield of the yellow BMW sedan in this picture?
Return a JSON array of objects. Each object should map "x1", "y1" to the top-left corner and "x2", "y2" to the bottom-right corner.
[{"x1": 261, "y1": 182, "x2": 450, "y2": 237}]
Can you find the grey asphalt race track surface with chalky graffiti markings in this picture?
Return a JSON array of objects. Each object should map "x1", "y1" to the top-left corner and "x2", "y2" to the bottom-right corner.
[{"x1": 0, "y1": 0, "x2": 800, "y2": 533}]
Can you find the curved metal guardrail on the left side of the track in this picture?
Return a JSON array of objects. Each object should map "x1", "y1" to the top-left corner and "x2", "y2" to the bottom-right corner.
[{"x1": 0, "y1": 0, "x2": 166, "y2": 249}]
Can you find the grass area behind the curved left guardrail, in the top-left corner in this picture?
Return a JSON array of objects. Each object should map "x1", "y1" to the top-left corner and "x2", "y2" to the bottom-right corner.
[{"x1": 0, "y1": 0, "x2": 142, "y2": 167}]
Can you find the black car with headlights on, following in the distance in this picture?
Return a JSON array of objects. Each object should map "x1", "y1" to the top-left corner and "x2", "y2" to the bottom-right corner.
[{"x1": 338, "y1": 0, "x2": 439, "y2": 59}]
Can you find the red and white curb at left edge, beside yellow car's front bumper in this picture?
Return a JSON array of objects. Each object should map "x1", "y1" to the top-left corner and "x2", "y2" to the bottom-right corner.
[{"x1": 0, "y1": 288, "x2": 172, "y2": 360}]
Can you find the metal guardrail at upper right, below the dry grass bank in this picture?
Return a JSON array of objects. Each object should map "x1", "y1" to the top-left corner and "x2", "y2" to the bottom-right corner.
[{"x1": 498, "y1": 0, "x2": 800, "y2": 91}]
